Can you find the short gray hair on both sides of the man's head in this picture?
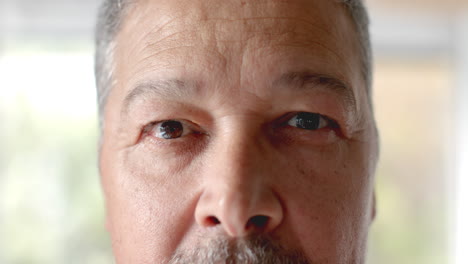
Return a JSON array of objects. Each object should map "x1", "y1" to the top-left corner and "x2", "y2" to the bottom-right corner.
[{"x1": 94, "y1": 0, "x2": 372, "y2": 128}]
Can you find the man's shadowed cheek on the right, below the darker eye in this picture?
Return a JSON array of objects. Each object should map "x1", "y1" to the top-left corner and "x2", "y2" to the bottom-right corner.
[{"x1": 282, "y1": 142, "x2": 372, "y2": 263}]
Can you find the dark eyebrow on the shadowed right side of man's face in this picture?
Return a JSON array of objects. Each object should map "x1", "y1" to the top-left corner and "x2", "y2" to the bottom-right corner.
[{"x1": 273, "y1": 71, "x2": 357, "y2": 112}]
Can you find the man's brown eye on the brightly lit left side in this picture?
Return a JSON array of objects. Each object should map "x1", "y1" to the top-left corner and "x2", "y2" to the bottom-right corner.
[{"x1": 148, "y1": 120, "x2": 192, "y2": 139}]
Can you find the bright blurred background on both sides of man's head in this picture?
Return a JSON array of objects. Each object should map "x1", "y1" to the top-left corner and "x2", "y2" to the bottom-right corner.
[{"x1": 0, "y1": 0, "x2": 468, "y2": 264}]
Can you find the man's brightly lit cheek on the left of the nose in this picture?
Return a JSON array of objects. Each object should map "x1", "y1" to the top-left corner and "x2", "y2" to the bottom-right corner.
[{"x1": 101, "y1": 147, "x2": 196, "y2": 263}]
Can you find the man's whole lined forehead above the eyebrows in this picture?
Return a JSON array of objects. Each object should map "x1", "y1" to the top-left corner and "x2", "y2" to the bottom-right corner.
[{"x1": 111, "y1": 0, "x2": 363, "y2": 105}]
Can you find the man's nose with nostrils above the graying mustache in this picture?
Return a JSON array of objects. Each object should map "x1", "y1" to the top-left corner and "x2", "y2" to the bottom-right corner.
[{"x1": 195, "y1": 129, "x2": 283, "y2": 237}]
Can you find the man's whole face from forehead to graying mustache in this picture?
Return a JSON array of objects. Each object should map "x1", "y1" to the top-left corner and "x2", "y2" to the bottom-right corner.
[{"x1": 100, "y1": 0, "x2": 377, "y2": 264}]
